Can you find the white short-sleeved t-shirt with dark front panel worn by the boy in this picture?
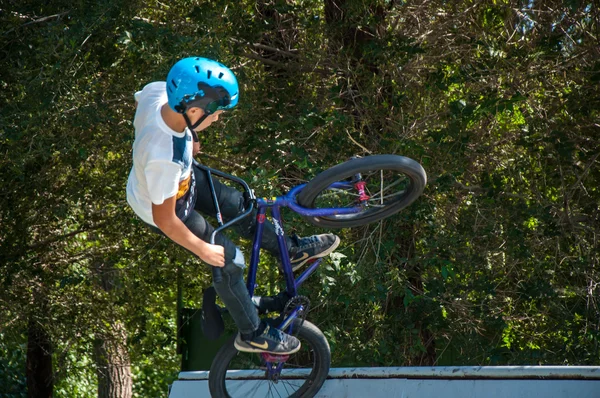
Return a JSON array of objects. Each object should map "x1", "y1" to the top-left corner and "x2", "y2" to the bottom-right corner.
[{"x1": 127, "y1": 82, "x2": 195, "y2": 226}]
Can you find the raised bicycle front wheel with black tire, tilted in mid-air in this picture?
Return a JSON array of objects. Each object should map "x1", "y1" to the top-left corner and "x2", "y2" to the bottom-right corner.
[{"x1": 297, "y1": 155, "x2": 427, "y2": 228}]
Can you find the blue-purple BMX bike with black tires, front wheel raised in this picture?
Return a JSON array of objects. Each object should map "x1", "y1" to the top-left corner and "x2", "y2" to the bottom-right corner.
[{"x1": 197, "y1": 155, "x2": 427, "y2": 397}]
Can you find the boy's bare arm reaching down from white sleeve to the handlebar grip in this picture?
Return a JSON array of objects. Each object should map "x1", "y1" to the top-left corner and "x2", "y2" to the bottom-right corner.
[{"x1": 152, "y1": 196, "x2": 225, "y2": 267}]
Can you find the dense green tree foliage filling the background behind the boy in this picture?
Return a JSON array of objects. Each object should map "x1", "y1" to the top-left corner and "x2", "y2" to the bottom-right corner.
[{"x1": 0, "y1": 0, "x2": 600, "y2": 397}]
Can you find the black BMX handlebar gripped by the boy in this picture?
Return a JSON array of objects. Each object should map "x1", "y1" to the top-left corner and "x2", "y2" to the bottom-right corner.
[{"x1": 193, "y1": 159, "x2": 256, "y2": 283}]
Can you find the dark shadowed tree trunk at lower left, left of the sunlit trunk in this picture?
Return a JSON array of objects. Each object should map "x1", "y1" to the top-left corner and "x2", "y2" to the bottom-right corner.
[{"x1": 27, "y1": 318, "x2": 54, "y2": 398}]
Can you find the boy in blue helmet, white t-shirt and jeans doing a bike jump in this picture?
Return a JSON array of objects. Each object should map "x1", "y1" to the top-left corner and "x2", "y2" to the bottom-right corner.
[{"x1": 127, "y1": 57, "x2": 340, "y2": 355}]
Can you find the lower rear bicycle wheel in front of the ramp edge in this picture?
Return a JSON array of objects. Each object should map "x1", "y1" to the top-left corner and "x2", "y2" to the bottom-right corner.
[{"x1": 208, "y1": 320, "x2": 331, "y2": 398}]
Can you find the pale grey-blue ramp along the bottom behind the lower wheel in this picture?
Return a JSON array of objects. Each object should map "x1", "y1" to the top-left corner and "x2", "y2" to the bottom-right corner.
[{"x1": 169, "y1": 366, "x2": 600, "y2": 398}]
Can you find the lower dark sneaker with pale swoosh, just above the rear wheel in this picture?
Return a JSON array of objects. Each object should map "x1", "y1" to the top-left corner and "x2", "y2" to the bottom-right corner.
[{"x1": 234, "y1": 325, "x2": 300, "y2": 355}]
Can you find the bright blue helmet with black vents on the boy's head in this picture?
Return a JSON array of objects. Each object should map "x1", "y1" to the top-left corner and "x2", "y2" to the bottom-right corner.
[{"x1": 167, "y1": 57, "x2": 239, "y2": 115}]
